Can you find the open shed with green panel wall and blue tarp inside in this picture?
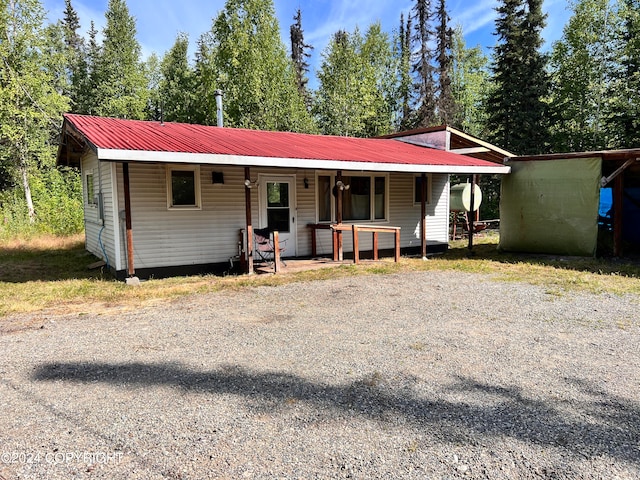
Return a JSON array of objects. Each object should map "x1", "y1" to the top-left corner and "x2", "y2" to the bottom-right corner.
[{"x1": 500, "y1": 149, "x2": 640, "y2": 256}]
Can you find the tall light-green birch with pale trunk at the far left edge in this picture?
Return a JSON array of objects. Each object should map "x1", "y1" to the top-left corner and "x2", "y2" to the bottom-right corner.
[{"x1": 0, "y1": 0, "x2": 68, "y2": 223}]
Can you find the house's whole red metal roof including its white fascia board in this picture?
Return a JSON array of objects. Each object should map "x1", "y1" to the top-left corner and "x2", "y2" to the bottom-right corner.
[{"x1": 58, "y1": 114, "x2": 510, "y2": 173}]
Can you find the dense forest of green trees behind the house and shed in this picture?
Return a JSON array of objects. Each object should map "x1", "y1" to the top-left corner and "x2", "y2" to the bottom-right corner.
[{"x1": 0, "y1": 0, "x2": 640, "y2": 240}]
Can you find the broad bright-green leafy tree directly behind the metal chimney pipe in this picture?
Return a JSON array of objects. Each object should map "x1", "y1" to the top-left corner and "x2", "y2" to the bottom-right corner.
[{"x1": 196, "y1": 0, "x2": 314, "y2": 132}]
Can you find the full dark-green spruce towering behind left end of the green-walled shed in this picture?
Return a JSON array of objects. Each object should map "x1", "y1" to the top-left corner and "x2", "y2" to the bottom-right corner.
[{"x1": 487, "y1": 0, "x2": 549, "y2": 155}]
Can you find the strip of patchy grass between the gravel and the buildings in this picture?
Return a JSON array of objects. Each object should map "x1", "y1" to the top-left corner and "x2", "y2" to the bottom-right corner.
[{"x1": 0, "y1": 235, "x2": 640, "y2": 317}]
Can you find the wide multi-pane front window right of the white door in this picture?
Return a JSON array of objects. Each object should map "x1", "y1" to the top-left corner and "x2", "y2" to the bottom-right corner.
[{"x1": 316, "y1": 175, "x2": 388, "y2": 222}]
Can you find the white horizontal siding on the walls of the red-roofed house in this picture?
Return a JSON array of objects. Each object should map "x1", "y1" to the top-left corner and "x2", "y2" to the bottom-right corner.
[{"x1": 109, "y1": 163, "x2": 448, "y2": 270}]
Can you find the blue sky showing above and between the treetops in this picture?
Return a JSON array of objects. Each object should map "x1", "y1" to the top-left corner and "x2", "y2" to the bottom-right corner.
[{"x1": 43, "y1": 0, "x2": 570, "y2": 76}]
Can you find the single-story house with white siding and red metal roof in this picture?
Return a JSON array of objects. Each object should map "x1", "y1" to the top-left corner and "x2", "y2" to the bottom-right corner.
[{"x1": 57, "y1": 114, "x2": 510, "y2": 278}]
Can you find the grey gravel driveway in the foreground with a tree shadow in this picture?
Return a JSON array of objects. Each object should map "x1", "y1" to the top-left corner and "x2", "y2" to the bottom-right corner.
[{"x1": 0, "y1": 272, "x2": 640, "y2": 480}]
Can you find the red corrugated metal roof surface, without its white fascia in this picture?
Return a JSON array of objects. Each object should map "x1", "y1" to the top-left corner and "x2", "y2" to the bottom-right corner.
[{"x1": 64, "y1": 114, "x2": 510, "y2": 169}]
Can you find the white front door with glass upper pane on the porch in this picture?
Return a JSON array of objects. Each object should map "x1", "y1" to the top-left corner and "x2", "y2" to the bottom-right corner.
[{"x1": 258, "y1": 175, "x2": 297, "y2": 257}]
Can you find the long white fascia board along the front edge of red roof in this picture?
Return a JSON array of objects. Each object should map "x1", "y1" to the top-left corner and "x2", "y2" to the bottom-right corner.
[{"x1": 96, "y1": 148, "x2": 511, "y2": 175}]
